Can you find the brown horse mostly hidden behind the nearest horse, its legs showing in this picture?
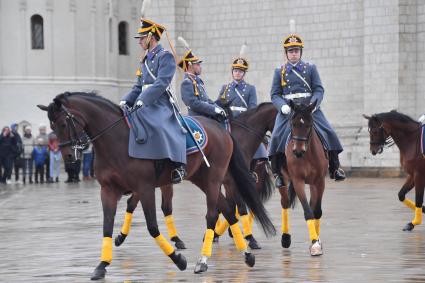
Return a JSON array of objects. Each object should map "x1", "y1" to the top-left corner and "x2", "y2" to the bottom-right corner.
[{"x1": 115, "y1": 103, "x2": 277, "y2": 249}]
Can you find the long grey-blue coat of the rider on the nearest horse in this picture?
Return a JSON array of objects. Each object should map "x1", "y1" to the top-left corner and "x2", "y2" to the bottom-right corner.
[{"x1": 123, "y1": 45, "x2": 186, "y2": 163}]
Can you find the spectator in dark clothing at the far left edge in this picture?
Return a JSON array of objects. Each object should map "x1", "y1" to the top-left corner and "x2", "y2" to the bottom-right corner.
[{"x1": 0, "y1": 126, "x2": 16, "y2": 184}]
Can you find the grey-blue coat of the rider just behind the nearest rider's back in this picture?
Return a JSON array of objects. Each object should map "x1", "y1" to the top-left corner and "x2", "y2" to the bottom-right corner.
[{"x1": 181, "y1": 73, "x2": 217, "y2": 117}]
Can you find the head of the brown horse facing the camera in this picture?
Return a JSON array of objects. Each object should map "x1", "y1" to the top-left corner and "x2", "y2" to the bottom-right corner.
[{"x1": 289, "y1": 100, "x2": 317, "y2": 158}]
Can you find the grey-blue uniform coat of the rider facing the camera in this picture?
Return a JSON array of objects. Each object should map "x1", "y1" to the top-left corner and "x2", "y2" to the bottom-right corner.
[{"x1": 269, "y1": 61, "x2": 342, "y2": 156}]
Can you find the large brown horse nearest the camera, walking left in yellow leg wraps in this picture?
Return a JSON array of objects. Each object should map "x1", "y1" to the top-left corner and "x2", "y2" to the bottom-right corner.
[{"x1": 38, "y1": 92, "x2": 275, "y2": 280}]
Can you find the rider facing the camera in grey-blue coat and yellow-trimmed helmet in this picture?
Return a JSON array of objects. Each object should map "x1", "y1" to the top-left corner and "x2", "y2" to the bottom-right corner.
[{"x1": 269, "y1": 34, "x2": 345, "y2": 187}]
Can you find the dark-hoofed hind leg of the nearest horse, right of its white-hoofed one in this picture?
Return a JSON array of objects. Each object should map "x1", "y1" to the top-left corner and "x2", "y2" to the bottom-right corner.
[{"x1": 218, "y1": 193, "x2": 255, "y2": 267}]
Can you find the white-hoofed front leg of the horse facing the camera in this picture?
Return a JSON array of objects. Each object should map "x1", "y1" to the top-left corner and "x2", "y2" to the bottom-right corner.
[{"x1": 293, "y1": 180, "x2": 322, "y2": 256}]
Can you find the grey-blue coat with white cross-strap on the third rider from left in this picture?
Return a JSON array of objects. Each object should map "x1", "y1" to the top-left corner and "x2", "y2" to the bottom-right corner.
[{"x1": 217, "y1": 80, "x2": 267, "y2": 159}]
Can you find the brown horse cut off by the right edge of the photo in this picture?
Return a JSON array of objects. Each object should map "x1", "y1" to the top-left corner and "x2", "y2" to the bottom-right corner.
[{"x1": 363, "y1": 110, "x2": 425, "y2": 231}]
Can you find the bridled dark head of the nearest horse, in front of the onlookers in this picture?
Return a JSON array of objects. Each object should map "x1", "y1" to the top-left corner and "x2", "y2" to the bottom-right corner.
[{"x1": 37, "y1": 93, "x2": 90, "y2": 163}]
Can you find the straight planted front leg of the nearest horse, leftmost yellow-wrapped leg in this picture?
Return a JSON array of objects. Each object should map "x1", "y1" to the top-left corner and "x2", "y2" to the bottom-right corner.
[{"x1": 91, "y1": 187, "x2": 119, "y2": 280}]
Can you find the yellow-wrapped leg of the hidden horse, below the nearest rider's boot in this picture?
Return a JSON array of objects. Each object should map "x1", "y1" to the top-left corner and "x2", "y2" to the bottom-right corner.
[{"x1": 161, "y1": 184, "x2": 186, "y2": 250}]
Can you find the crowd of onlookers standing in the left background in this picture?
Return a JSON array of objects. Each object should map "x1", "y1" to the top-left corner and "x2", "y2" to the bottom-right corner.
[{"x1": 0, "y1": 124, "x2": 94, "y2": 184}]
